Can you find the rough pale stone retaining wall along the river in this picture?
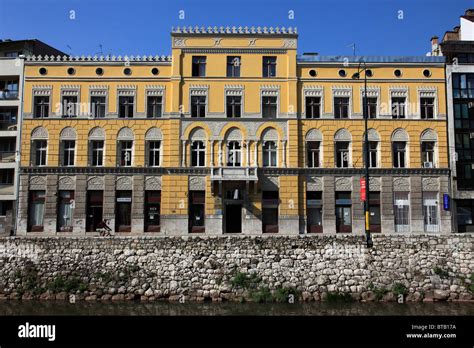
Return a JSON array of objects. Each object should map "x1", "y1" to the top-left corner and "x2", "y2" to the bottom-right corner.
[{"x1": 0, "y1": 234, "x2": 474, "y2": 302}]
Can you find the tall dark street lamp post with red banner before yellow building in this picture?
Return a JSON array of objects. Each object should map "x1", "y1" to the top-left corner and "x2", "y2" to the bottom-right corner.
[{"x1": 352, "y1": 60, "x2": 374, "y2": 248}]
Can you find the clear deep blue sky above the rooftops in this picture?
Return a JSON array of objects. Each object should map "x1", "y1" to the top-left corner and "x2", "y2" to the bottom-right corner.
[{"x1": 0, "y1": 0, "x2": 474, "y2": 55}]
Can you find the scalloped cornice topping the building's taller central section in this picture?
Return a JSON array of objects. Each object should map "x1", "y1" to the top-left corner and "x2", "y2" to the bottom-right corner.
[{"x1": 171, "y1": 26, "x2": 298, "y2": 35}]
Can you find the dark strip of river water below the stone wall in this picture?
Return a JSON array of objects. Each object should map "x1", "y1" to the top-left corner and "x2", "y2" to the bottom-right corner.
[{"x1": 0, "y1": 301, "x2": 474, "y2": 316}]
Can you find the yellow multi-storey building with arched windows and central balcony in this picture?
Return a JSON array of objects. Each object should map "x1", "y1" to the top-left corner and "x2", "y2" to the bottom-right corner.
[{"x1": 18, "y1": 28, "x2": 451, "y2": 235}]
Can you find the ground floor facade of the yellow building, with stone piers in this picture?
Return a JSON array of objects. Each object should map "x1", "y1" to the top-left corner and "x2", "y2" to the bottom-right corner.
[{"x1": 17, "y1": 170, "x2": 452, "y2": 236}]
